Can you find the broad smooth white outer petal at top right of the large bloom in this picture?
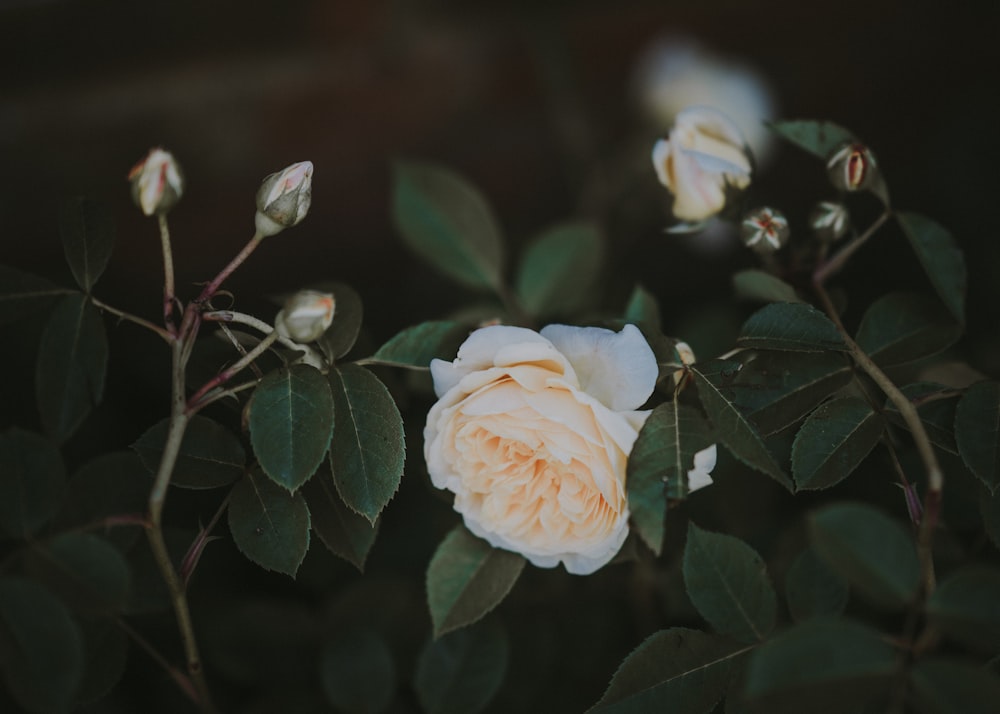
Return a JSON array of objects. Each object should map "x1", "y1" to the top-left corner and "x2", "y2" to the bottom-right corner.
[{"x1": 541, "y1": 325, "x2": 659, "y2": 411}]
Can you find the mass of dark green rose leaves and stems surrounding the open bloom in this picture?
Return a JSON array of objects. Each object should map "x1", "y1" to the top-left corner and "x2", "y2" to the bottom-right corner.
[{"x1": 0, "y1": 107, "x2": 1000, "y2": 714}]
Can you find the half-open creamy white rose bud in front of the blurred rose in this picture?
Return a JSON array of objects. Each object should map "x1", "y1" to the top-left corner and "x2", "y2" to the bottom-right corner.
[{"x1": 653, "y1": 107, "x2": 751, "y2": 222}]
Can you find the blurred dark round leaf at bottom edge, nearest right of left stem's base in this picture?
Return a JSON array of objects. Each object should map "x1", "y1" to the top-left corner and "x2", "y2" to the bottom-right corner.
[{"x1": 319, "y1": 629, "x2": 396, "y2": 714}]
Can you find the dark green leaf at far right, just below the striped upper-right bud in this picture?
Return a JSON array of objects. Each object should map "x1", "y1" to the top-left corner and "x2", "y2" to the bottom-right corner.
[{"x1": 896, "y1": 211, "x2": 966, "y2": 322}]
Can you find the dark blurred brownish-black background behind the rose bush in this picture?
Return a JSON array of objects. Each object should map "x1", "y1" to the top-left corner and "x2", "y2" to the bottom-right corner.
[{"x1": 0, "y1": 0, "x2": 1000, "y2": 711}]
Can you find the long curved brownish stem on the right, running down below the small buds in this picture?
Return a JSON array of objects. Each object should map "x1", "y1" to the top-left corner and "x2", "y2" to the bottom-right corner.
[{"x1": 813, "y1": 210, "x2": 944, "y2": 595}]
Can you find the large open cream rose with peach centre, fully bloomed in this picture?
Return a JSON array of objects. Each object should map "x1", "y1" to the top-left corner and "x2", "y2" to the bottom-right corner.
[{"x1": 424, "y1": 325, "x2": 658, "y2": 575}]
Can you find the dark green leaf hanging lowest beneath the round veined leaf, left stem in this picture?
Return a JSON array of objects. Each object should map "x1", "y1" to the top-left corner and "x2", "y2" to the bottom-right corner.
[{"x1": 229, "y1": 472, "x2": 309, "y2": 578}]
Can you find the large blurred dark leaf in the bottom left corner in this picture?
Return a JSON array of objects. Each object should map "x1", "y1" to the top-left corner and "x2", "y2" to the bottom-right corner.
[{"x1": 0, "y1": 577, "x2": 84, "y2": 712}]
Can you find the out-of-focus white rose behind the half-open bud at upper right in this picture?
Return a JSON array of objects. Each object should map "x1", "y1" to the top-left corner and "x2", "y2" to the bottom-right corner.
[{"x1": 635, "y1": 38, "x2": 776, "y2": 165}]
